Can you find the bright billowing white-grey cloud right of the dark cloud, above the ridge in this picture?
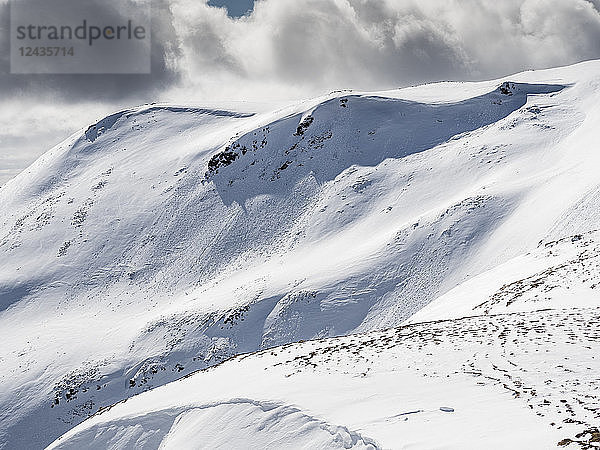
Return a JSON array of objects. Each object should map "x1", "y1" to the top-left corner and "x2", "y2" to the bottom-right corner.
[{"x1": 166, "y1": 0, "x2": 600, "y2": 99}]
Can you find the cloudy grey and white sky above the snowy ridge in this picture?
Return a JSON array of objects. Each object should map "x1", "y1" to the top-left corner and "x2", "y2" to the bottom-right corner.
[{"x1": 0, "y1": 0, "x2": 600, "y2": 184}]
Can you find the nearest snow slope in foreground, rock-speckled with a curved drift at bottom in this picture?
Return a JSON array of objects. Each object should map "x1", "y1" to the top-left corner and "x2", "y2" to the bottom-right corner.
[{"x1": 49, "y1": 308, "x2": 600, "y2": 449}]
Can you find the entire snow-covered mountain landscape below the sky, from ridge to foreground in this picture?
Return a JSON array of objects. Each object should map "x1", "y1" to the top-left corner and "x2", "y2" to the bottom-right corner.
[{"x1": 0, "y1": 61, "x2": 600, "y2": 449}]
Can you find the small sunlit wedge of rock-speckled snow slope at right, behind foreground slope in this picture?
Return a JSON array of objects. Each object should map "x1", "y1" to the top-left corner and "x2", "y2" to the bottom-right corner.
[{"x1": 407, "y1": 231, "x2": 600, "y2": 323}]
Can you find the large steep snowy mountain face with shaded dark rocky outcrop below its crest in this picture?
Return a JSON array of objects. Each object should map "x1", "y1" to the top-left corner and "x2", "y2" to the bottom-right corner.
[{"x1": 0, "y1": 62, "x2": 600, "y2": 448}]
